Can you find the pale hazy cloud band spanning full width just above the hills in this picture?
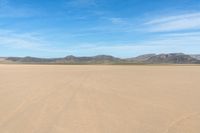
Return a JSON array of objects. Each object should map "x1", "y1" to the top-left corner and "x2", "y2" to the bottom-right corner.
[{"x1": 0, "y1": 30, "x2": 200, "y2": 57}]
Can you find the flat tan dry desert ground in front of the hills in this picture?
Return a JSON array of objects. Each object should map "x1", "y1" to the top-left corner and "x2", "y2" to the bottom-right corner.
[{"x1": 0, "y1": 65, "x2": 200, "y2": 133}]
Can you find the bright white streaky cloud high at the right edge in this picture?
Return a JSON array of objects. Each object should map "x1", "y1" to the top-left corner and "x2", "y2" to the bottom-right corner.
[{"x1": 144, "y1": 12, "x2": 200, "y2": 32}]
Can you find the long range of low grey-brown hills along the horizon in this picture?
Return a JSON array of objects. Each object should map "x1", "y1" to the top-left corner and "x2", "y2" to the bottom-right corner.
[{"x1": 0, "y1": 53, "x2": 200, "y2": 64}]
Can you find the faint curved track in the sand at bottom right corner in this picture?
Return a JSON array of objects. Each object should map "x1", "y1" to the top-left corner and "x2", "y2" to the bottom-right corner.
[{"x1": 163, "y1": 112, "x2": 200, "y2": 133}]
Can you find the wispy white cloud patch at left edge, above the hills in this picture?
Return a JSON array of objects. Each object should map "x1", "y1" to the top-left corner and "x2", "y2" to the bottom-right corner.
[{"x1": 0, "y1": 30, "x2": 79, "y2": 56}]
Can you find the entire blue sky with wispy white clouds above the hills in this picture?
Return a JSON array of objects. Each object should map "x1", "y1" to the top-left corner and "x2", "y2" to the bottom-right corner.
[{"x1": 0, "y1": 0, "x2": 200, "y2": 58}]
